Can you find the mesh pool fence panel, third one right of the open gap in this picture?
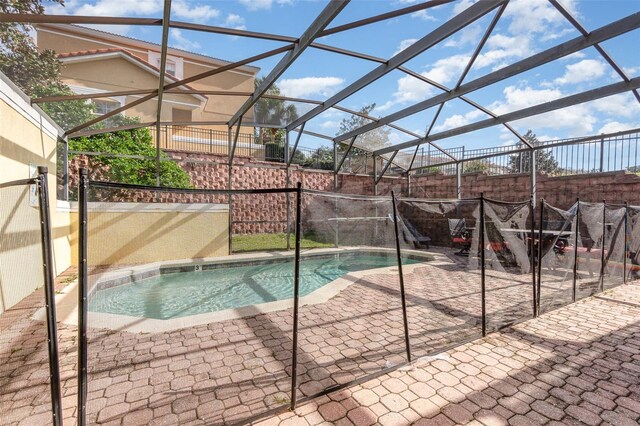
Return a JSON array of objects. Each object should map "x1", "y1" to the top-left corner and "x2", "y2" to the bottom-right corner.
[{"x1": 398, "y1": 198, "x2": 483, "y2": 358}]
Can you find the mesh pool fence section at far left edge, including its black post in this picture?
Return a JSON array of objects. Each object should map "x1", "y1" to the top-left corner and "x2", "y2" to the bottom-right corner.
[{"x1": 0, "y1": 171, "x2": 62, "y2": 426}]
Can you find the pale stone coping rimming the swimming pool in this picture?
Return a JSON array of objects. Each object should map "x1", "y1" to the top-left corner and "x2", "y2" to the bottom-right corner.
[{"x1": 33, "y1": 247, "x2": 441, "y2": 333}]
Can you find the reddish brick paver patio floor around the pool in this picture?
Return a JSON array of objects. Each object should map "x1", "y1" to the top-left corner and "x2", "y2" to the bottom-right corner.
[{"x1": 0, "y1": 251, "x2": 640, "y2": 425}]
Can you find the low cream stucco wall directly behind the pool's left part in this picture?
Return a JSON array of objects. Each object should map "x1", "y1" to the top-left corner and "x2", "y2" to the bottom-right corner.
[{"x1": 71, "y1": 203, "x2": 229, "y2": 266}]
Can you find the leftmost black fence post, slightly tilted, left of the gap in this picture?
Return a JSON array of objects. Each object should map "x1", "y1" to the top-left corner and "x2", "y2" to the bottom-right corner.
[{"x1": 38, "y1": 166, "x2": 62, "y2": 426}]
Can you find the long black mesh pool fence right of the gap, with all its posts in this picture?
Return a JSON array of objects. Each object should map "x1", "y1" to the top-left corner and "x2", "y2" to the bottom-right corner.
[{"x1": 72, "y1": 171, "x2": 640, "y2": 424}]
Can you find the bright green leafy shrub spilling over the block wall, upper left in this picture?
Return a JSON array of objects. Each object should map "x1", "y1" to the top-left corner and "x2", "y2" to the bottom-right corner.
[{"x1": 69, "y1": 115, "x2": 192, "y2": 188}]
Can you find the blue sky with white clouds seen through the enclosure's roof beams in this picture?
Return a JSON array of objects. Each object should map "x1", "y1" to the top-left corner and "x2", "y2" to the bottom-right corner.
[{"x1": 42, "y1": 0, "x2": 640, "y2": 153}]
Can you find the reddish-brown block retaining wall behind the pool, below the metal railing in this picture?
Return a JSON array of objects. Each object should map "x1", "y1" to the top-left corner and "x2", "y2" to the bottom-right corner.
[{"x1": 69, "y1": 151, "x2": 640, "y2": 233}]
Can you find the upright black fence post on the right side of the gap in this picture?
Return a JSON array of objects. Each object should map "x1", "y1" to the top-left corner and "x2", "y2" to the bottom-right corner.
[{"x1": 78, "y1": 168, "x2": 89, "y2": 426}]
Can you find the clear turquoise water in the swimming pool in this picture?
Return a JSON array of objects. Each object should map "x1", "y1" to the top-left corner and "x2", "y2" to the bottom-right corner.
[{"x1": 89, "y1": 253, "x2": 424, "y2": 319}]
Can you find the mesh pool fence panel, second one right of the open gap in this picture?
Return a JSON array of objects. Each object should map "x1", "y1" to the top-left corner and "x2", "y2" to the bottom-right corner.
[{"x1": 298, "y1": 191, "x2": 411, "y2": 397}]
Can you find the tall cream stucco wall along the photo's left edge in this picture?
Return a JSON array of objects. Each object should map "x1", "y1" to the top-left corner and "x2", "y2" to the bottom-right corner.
[{"x1": 0, "y1": 75, "x2": 71, "y2": 312}]
